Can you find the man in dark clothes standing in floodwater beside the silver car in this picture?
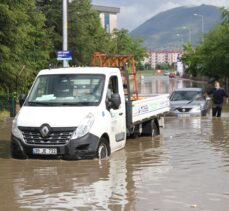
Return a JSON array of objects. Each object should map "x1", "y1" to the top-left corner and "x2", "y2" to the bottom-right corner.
[{"x1": 207, "y1": 81, "x2": 228, "y2": 117}]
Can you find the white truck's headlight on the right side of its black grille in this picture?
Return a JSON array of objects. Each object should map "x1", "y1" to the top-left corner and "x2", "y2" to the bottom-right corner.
[{"x1": 71, "y1": 113, "x2": 95, "y2": 139}]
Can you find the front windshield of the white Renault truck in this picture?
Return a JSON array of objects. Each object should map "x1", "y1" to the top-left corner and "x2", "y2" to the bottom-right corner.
[{"x1": 26, "y1": 74, "x2": 105, "y2": 106}]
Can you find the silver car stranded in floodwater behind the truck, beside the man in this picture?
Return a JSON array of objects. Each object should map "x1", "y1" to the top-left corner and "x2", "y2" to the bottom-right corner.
[{"x1": 169, "y1": 88, "x2": 211, "y2": 116}]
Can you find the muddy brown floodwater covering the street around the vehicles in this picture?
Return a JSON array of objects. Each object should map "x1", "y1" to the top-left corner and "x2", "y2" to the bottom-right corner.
[{"x1": 0, "y1": 78, "x2": 229, "y2": 211}]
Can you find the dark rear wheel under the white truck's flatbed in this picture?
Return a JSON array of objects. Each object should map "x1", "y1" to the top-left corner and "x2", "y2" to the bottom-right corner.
[{"x1": 142, "y1": 119, "x2": 160, "y2": 137}]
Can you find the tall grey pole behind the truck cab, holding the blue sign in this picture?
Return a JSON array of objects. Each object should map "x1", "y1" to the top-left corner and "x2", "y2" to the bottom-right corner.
[{"x1": 63, "y1": 0, "x2": 69, "y2": 67}]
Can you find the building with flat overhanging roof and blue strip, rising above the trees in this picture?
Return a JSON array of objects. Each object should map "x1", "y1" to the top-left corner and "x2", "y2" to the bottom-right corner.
[{"x1": 93, "y1": 5, "x2": 120, "y2": 33}]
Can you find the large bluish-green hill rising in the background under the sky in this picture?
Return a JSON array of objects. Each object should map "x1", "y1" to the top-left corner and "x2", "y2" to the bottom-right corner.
[{"x1": 130, "y1": 5, "x2": 221, "y2": 49}]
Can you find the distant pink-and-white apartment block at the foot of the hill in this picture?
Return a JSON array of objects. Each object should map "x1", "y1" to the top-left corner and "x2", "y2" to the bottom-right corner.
[{"x1": 144, "y1": 49, "x2": 182, "y2": 69}]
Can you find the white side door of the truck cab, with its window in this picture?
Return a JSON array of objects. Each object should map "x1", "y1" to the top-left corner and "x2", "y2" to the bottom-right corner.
[{"x1": 107, "y1": 76, "x2": 126, "y2": 148}]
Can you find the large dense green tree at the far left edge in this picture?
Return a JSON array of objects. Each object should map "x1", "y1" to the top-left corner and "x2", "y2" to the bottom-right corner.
[{"x1": 0, "y1": 0, "x2": 51, "y2": 92}]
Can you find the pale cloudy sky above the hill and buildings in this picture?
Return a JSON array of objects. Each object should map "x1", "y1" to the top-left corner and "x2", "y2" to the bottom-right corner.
[{"x1": 92, "y1": 0, "x2": 229, "y2": 31}]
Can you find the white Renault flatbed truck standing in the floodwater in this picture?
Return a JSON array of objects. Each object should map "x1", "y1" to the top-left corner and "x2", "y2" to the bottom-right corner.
[{"x1": 11, "y1": 67, "x2": 169, "y2": 159}]
